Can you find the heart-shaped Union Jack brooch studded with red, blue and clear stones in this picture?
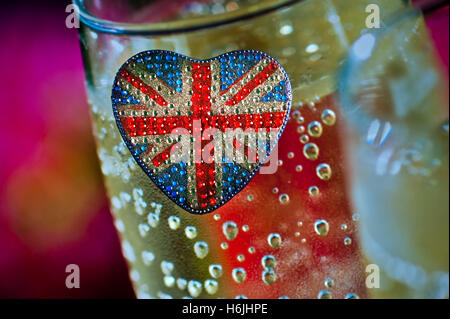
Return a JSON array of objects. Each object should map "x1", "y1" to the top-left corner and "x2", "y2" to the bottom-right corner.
[{"x1": 112, "y1": 50, "x2": 292, "y2": 214}]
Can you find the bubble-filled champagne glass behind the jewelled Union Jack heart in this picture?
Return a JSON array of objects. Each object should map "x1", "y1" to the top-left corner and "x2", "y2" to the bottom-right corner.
[{"x1": 74, "y1": 0, "x2": 408, "y2": 298}]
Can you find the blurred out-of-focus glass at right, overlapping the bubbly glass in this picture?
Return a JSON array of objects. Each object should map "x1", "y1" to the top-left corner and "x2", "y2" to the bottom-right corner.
[{"x1": 339, "y1": 5, "x2": 449, "y2": 298}]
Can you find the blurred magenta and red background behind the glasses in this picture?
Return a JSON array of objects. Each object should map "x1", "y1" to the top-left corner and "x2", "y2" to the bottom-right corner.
[{"x1": 0, "y1": 0, "x2": 449, "y2": 298}]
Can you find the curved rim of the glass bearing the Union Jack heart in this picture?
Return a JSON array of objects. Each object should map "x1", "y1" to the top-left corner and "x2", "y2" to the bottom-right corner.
[{"x1": 73, "y1": 0, "x2": 306, "y2": 35}]
